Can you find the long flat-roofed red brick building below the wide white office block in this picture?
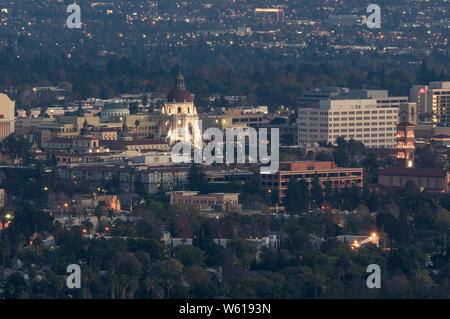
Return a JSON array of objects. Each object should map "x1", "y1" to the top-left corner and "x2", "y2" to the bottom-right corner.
[{"x1": 261, "y1": 162, "x2": 364, "y2": 203}]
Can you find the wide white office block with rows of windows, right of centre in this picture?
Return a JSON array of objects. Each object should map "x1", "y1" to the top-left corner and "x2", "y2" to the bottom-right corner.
[{"x1": 297, "y1": 97, "x2": 403, "y2": 148}]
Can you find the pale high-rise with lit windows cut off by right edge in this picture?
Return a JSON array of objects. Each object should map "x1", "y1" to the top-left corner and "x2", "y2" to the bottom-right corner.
[{"x1": 409, "y1": 81, "x2": 450, "y2": 123}]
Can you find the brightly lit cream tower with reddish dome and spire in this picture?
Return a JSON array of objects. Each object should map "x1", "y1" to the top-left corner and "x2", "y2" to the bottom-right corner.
[{"x1": 161, "y1": 68, "x2": 201, "y2": 145}]
